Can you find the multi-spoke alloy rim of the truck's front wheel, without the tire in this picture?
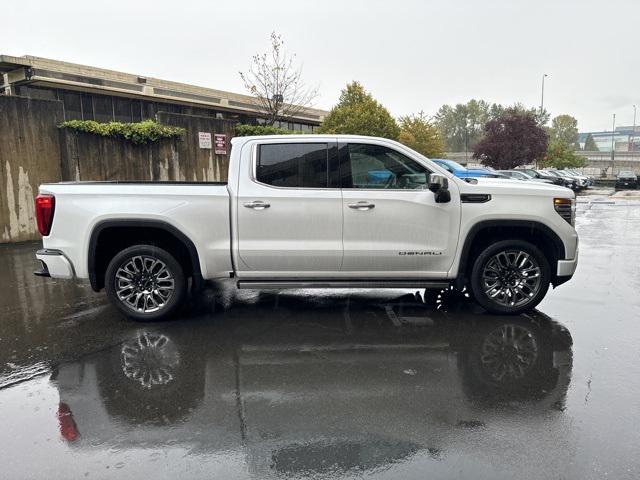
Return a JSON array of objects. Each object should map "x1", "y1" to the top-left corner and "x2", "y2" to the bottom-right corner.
[{"x1": 482, "y1": 250, "x2": 542, "y2": 307}]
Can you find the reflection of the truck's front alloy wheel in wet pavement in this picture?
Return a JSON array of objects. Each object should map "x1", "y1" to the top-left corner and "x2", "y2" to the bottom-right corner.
[{"x1": 480, "y1": 323, "x2": 539, "y2": 382}]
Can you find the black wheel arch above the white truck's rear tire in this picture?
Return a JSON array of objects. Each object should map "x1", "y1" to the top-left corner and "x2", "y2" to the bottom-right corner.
[{"x1": 87, "y1": 219, "x2": 204, "y2": 292}]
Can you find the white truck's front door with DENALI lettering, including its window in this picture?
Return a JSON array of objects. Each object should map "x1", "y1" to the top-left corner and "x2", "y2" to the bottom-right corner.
[{"x1": 340, "y1": 143, "x2": 460, "y2": 278}]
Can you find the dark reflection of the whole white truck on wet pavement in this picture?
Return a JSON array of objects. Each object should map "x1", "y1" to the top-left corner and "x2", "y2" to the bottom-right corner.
[{"x1": 51, "y1": 295, "x2": 571, "y2": 476}]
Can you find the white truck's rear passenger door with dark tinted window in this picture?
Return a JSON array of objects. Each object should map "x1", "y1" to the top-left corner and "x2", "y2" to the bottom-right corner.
[{"x1": 236, "y1": 138, "x2": 342, "y2": 278}]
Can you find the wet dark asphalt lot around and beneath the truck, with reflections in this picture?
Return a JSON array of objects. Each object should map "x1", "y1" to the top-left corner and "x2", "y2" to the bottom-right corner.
[{"x1": 0, "y1": 195, "x2": 640, "y2": 479}]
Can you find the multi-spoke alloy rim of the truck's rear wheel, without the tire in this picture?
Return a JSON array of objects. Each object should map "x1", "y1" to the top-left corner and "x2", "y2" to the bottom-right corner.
[{"x1": 116, "y1": 255, "x2": 175, "y2": 313}]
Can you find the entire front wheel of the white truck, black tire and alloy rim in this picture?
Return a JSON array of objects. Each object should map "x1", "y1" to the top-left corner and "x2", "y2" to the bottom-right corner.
[{"x1": 471, "y1": 240, "x2": 551, "y2": 315}]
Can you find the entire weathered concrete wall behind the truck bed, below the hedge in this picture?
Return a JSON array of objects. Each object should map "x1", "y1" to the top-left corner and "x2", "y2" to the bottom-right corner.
[{"x1": 0, "y1": 95, "x2": 235, "y2": 243}]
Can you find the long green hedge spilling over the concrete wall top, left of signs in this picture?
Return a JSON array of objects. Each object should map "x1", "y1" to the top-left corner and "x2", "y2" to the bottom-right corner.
[{"x1": 58, "y1": 120, "x2": 185, "y2": 145}]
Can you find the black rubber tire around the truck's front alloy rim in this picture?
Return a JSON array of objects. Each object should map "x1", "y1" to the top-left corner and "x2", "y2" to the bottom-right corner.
[{"x1": 470, "y1": 239, "x2": 551, "y2": 315}]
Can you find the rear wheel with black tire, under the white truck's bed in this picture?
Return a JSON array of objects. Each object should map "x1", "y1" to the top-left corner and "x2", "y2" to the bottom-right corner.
[{"x1": 105, "y1": 245, "x2": 187, "y2": 321}]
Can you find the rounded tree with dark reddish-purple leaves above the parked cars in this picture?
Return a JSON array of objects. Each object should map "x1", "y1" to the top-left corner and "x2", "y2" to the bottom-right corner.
[{"x1": 473, "y1": 112, "x2": 547, "y2": 169}]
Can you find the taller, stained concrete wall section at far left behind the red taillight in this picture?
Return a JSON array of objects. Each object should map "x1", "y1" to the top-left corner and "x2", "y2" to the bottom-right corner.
[{"x1": 0, "y1": 95, "x2": 63, "y2": 243}]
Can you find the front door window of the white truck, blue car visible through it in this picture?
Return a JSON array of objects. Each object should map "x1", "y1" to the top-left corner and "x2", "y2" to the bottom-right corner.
[{"x1": 343, "y1": 143, "x2": 429, "y2": 190}]
